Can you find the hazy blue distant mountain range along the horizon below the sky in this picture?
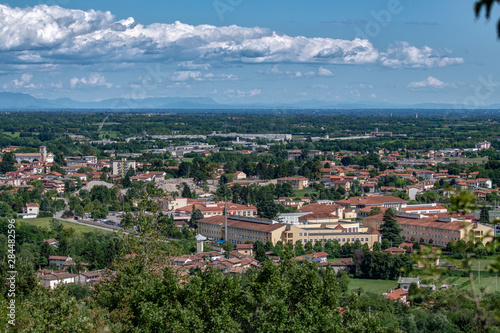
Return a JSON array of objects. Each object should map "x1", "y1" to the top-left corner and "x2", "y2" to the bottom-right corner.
[{"x1": 0, "y1": 92, "x2": 500, "y2": 111}]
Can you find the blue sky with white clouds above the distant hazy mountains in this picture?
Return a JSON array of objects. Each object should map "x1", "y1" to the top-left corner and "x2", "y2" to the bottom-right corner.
[{"x1": 0, "y1": 0, "x2": 500, "y2": 107}]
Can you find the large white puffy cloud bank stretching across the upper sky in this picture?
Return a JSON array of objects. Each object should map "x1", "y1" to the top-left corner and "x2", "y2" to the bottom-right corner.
[{"x1": 0, "y1": 5, "x2": 464, "y2": 69}]
